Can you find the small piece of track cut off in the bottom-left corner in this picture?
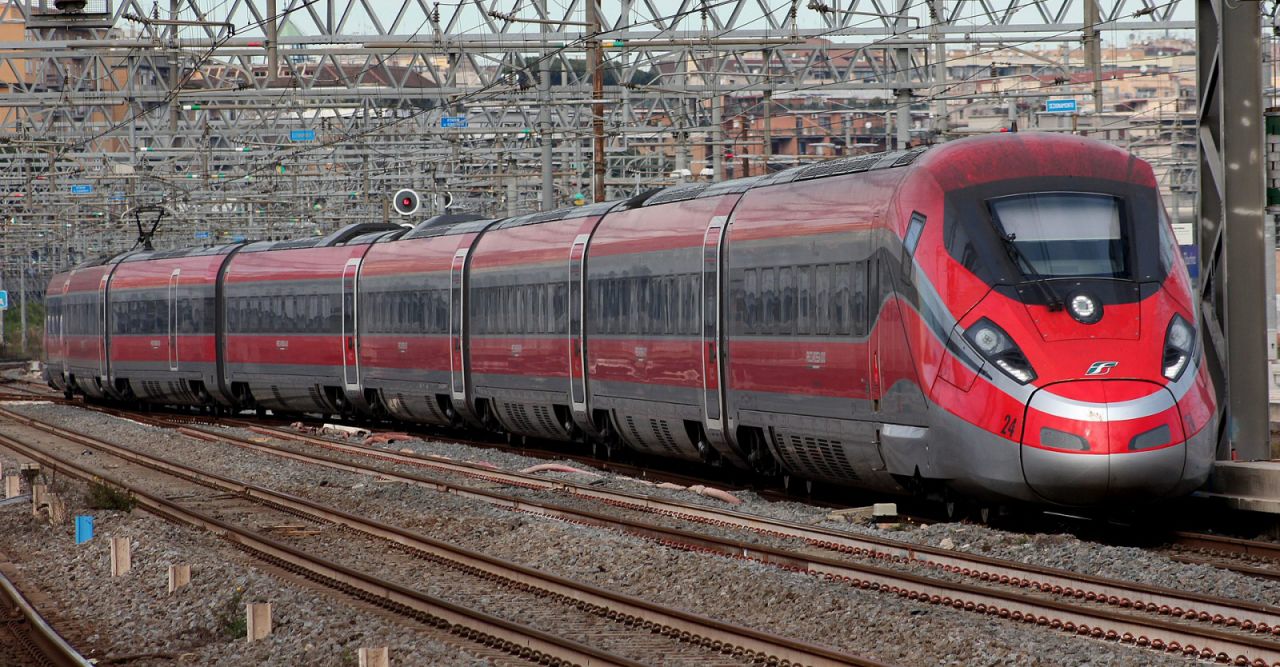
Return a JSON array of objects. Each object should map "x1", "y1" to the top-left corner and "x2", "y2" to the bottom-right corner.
[{"x1": 0, "y1": 565, "x2": 91, "y2": 667}]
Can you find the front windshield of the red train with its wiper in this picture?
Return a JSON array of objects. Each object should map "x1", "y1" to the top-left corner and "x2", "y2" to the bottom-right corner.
[{"x1": 988, "y1": 192, "x2": 1128, "y2": 280}]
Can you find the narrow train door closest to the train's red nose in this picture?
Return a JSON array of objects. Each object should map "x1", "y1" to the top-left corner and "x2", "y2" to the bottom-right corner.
[{"x1": 701, "y1": 215, "x2": 728, "y2": 443}]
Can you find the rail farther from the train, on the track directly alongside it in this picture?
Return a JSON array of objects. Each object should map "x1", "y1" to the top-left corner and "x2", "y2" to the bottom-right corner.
[{"x1": 112, "y1": 414, "x2": 1280, "y2": 666}]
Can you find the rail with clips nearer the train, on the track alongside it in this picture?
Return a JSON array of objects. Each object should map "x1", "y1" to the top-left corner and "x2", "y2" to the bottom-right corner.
[{"x1": 240, "y1": 426, "x2": 1280, "y2": 634}]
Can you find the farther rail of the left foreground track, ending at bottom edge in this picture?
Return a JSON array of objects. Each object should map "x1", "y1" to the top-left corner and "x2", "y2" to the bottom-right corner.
[{"x1": 0, "y1": 411, "x2": 883, "y2": 667}]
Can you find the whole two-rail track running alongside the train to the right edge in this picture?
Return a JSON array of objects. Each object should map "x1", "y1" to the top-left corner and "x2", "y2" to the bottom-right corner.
[{"x1": 77, "y1": 409, "x2": 1280, "y2": 666}]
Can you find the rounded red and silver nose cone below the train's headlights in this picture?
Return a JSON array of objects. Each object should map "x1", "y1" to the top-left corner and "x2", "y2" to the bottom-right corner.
[{"x1": 1019, "y1": 380, "x2": 1187, "y2": 506}]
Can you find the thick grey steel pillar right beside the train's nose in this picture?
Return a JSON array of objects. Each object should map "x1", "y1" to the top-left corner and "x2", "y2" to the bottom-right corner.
[{"x1": 1197, "y1": 0, "x2": 1275, "y2": 460}]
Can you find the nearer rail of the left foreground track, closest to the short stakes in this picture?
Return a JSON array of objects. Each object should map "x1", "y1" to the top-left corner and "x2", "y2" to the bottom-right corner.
[{"x1": 0, "y1": 434, "x2": 643, "y2": 667}]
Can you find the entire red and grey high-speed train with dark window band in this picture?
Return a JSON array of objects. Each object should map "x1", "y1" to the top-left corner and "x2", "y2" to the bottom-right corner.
[{"x1": 45, "y1": 133, "x2": 1219, "y2": 507}]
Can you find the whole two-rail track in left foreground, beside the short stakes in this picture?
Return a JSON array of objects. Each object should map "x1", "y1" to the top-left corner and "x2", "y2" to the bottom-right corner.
[{"x1": 0, "y1": 401, "x2": 878, "y2": 664}]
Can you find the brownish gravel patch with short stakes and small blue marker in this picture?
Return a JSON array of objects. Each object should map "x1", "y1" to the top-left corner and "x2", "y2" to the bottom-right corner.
[{"x1": 0, "y1": 453, "x2": 485, "y2": 667}]
